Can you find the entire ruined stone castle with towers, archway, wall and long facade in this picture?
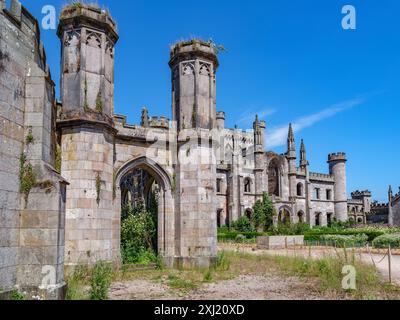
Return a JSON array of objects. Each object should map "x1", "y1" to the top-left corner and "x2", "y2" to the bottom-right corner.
[{"x1": 0, "y1": 0, "x2": 376, "y2": 298}]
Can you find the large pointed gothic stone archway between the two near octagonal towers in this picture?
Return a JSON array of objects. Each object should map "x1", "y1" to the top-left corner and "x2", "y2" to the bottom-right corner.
[{"x1": 113, "y1": 157, "x2": 175, "y2": 264}]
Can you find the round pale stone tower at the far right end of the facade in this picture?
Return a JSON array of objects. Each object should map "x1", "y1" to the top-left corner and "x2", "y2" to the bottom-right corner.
[{"x1": 328, "y1": 152, "x2": 348, "y2": 221}]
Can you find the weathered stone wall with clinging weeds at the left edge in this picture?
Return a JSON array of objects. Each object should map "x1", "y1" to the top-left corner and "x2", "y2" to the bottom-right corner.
[{"x1": 0, "y1": 1, "x2": 66, "y2": 298}]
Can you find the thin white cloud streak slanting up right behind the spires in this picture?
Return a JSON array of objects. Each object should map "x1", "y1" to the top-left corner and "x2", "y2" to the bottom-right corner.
[{"x1": 266, "y1": 98, "x2": 365, "y2": 148}]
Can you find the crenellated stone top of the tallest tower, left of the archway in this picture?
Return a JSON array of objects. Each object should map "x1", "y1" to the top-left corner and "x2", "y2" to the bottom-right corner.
[{"x1": 57, "y1": 2, "x2": 118, "y2": 42}]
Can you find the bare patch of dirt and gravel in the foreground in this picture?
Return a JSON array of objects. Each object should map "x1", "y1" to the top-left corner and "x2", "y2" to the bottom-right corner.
[{"x1": 109, "y1": 275, "x2": 329, "y2": 300}]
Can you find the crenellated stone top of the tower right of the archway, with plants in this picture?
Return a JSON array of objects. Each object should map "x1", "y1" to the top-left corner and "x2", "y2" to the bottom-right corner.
[{"x1": 170, "y1": 39, "x2": 219, "y2": 68}]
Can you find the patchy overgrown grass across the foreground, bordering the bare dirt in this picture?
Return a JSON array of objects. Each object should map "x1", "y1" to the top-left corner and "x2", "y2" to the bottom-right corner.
[{"x1": 68, "y1": 249, "x2": 400, "y2": 300}]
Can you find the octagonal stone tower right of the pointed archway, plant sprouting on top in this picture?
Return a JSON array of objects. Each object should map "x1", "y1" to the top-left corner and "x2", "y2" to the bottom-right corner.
[{"x1": 169, "y1": 40, "x2": 218, "y2": 267}]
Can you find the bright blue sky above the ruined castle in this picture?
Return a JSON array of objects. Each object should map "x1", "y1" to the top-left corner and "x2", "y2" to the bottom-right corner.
[{"x1": 18, "y1": 0, "x2": 400, "y2": 201}]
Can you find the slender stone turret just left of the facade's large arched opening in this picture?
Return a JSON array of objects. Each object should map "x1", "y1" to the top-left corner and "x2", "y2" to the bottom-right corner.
[{"x1": 253, "y1": 115, "x2": 268, "y2": 200}]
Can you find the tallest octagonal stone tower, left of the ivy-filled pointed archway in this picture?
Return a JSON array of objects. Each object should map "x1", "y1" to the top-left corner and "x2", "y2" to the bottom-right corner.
[{"x1": 58, "y1": 4, "x2": 119, "y2": 264}]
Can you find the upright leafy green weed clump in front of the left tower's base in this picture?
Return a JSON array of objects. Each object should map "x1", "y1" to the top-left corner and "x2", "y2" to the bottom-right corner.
[{"x1": 90, "y1": 262, "x2": 112, "y2": 300}]
